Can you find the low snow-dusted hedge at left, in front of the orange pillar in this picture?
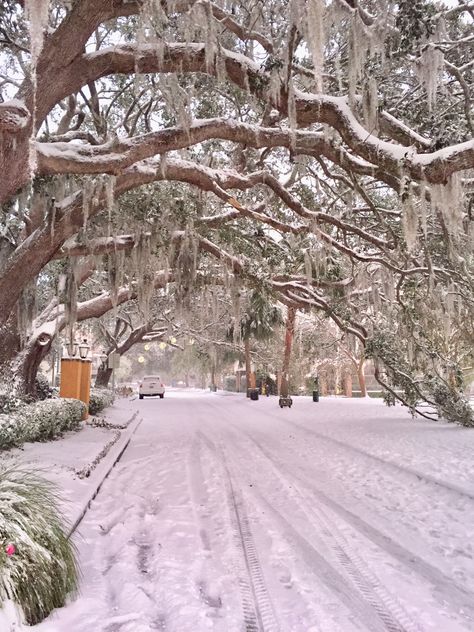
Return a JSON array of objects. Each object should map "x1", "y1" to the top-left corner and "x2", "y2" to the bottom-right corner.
[{"x1": 0, "y1": 399, "x2": 85, "y2": 450}]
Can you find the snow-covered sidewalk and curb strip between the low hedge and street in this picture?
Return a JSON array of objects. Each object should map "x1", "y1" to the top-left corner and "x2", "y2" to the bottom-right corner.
[{"x1": 0, "y1": 398, "x2": 141, "y2": 529}]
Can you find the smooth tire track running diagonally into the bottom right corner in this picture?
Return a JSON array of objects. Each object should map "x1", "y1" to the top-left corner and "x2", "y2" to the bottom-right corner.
[{"x1": 241, "y1": 433, "x2": 474, "y2": 620}]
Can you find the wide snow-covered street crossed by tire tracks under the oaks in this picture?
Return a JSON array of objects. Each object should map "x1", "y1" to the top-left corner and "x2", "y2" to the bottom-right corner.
[{"x1": 33, "y1": 392, "x2": 474, "y2": 632}]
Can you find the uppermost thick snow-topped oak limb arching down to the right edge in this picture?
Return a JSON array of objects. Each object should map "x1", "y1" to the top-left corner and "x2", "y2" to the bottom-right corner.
[{"x1": 65, "y1": 43, "x2": 474, "y2": 183}]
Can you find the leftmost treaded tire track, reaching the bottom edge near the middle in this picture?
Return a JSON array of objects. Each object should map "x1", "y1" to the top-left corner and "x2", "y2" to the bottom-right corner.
[{"x1": 198, "y1": 432, "x2": 280, "y2": 632}]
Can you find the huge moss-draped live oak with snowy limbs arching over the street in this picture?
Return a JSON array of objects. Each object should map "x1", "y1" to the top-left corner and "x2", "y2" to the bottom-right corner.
[{"x1": 0, "y1": 0, "x2": 474, "y2": 424}]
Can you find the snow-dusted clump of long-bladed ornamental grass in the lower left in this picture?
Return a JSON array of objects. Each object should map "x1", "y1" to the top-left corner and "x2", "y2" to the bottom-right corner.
[{"x1": 0, "y1": 469, "x2": 78, "y2": 625}]
